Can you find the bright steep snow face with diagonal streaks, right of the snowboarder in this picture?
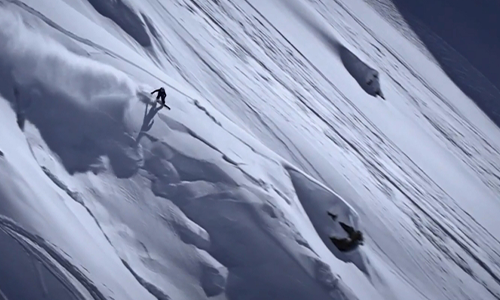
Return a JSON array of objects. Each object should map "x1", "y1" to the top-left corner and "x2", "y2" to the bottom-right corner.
[{"x1": 159, "y1": 1, "x2": 499, "y2": 298}]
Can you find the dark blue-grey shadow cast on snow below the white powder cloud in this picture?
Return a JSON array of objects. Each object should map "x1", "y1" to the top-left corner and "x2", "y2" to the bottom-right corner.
[{"x1": 7, "y1": 81, "x2": 143, "y2": 178}]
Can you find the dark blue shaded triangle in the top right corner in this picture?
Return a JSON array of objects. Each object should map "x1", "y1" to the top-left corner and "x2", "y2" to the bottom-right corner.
[{"x1": 388, "y1": 0, "x2": 500, "y2": 126}]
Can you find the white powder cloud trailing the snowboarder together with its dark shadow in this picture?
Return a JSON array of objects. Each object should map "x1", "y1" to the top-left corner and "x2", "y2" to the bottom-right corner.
[{"x1": 0, "y1": 9, "x2": 142, "y2": 177}]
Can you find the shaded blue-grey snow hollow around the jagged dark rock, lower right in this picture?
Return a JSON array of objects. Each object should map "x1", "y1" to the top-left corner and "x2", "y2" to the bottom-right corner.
[{"x1": 288, "y1": 169, "x2": 370, "y2": 275}]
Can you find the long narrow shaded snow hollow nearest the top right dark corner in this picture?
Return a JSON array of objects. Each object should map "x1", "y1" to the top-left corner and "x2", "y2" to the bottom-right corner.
[{"x1": 282, "y1": 0, "x2": 385, "y2": 100}]
